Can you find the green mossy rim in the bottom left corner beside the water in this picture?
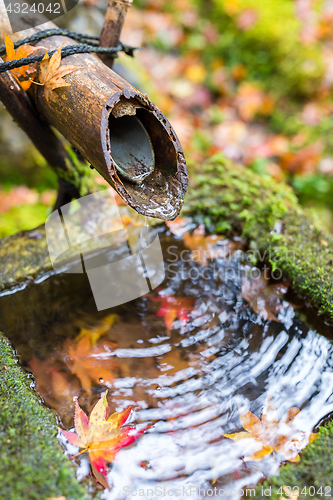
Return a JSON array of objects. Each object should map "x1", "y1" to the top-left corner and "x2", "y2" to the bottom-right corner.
[{"x1": 0, "y1": 334, "x2": 90, "y2": 500}]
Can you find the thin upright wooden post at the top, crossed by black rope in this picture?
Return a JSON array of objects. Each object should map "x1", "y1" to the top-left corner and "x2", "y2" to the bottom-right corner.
[{"x1": 99, "y1": 0, "x2": 133, "y2": 68}]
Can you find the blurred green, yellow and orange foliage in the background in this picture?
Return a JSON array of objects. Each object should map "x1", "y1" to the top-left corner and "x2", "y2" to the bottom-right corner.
[{"x1": 0, "y1": 0, "x2": 333, "y2": 236}]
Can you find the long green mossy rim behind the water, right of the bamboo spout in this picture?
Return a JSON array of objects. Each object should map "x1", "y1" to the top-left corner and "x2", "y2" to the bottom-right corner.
[{"x1": 184, "y1": 154, "x2": 333, "y2": 320}]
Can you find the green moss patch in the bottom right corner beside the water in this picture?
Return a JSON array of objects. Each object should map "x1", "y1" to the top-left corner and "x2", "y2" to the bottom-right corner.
[{"x1": 255, "y1": 422, "x2": 333, "y2": 500}]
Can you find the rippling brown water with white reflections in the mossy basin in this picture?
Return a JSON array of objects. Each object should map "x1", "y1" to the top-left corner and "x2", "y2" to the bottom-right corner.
[{"x1": 0, "y1": 227, "x2": 333, "y2": 500}]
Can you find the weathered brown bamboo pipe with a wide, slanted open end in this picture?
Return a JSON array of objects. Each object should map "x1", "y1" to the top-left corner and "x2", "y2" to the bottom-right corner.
[{"x1": 0, "y1": 2, "x2": 188, "y2": 220}]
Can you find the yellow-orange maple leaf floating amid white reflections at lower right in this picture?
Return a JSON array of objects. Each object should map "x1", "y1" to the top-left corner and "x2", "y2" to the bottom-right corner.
[{"x1": 224, "y1": 396, "x2": 317, "y2": 462}]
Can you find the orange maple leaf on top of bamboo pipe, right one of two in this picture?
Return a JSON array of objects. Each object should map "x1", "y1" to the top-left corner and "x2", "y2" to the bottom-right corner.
[{"x1": 39, "y1": 44, "x2": 82, "y2": 101}]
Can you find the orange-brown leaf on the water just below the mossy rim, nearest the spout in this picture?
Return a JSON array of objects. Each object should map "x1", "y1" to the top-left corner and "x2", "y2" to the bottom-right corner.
[{"x1": 183, "y1": 224, "x2": 239, "y2": 266}]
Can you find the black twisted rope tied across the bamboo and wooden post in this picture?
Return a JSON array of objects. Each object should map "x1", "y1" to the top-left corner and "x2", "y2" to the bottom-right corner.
[{"x1": 0, "y1": 29, "x2": 139, "y2": 73}]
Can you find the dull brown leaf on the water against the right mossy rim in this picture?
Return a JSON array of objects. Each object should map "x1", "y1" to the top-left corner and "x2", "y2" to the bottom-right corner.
[{"x1": 242, "y1": 273, "x2": 288, "y2": 321}]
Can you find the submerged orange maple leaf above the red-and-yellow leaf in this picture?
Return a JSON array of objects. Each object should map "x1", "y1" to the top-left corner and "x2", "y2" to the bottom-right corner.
[{"x1": 64, "y1": 335, "x2": 117, "y2": 394}]
